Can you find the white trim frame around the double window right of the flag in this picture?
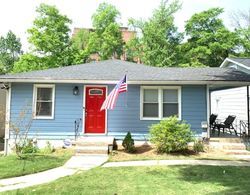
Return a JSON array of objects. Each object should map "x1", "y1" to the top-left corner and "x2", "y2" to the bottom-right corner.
[{"x1": 140, "y1": 86, "x2": 182, "y2": 120}]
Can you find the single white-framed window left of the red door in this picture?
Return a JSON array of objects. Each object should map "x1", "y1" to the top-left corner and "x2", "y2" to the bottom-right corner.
[{"x1": 33, "y1": 85, "x2": 55, "y2": 119}]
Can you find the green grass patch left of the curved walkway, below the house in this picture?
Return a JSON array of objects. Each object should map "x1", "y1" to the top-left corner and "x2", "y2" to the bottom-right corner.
[{"x1": 0, "y1": 149, "x2": 73, "y2": 179}]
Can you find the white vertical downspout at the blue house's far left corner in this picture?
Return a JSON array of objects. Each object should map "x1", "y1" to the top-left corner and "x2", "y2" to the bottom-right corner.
[{"x1": 4, "y1": 83, "x2": 11, "y2": 155}]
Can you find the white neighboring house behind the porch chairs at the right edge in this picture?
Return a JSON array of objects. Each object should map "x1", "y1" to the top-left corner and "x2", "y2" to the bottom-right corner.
[{"x1": 211, "y1": 58, "x2": 250, "y2": 131}]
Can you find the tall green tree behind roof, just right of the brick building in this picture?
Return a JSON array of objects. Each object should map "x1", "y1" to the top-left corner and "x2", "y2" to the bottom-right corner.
[{"x1": 129, "y1": 1, "x2": 183, "y2": 66}]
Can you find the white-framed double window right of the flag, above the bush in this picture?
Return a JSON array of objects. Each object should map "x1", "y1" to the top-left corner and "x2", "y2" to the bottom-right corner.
[{"x1": 140, "y1": 86, "x2": 181, "y2": 120}]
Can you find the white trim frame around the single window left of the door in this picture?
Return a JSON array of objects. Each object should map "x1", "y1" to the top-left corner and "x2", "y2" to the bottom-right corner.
[{"x1": 32, "y1": 84, "x2": 55, "y2": 119}]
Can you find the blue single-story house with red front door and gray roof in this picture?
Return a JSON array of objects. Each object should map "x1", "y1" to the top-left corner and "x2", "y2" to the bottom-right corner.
[{"x1": 0, "y1": 60, "x2": 250, "y2": 152}]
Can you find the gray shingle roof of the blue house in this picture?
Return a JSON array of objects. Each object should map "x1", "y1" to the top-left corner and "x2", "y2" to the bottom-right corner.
[{"x1": 0, "y1": 60, "x2": 250, "y2": 82}]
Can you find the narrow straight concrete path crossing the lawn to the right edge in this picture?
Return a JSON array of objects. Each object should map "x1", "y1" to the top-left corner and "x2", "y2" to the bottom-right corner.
[{"x1": 102, "y1": 160, "x2": 250, "y2": 167}]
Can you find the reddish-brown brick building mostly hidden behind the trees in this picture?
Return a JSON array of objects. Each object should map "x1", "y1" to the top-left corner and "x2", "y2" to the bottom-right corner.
[{"x1": 72, "y1": 27, "x2": 136, "y2": 62}]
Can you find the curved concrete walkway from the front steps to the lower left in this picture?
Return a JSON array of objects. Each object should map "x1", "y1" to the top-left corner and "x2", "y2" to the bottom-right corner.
[{"x1": 0, "y1": 155, "x2": 108, "y2": 192}]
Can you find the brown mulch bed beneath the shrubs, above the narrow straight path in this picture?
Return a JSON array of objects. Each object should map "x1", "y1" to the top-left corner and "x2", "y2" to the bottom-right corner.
[{"x1": 109, "y1": 144, "x2": 242, "y2": 162}]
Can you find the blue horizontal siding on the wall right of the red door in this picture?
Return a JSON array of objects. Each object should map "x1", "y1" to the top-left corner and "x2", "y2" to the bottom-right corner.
[{"x1": 108, "y1": 85, "x2": 207, "y2": 135}]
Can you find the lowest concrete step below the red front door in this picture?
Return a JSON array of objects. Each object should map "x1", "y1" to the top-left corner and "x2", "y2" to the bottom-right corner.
[{"x1": 75, "y1": 146, "x2": 108, "y2": 154}]
